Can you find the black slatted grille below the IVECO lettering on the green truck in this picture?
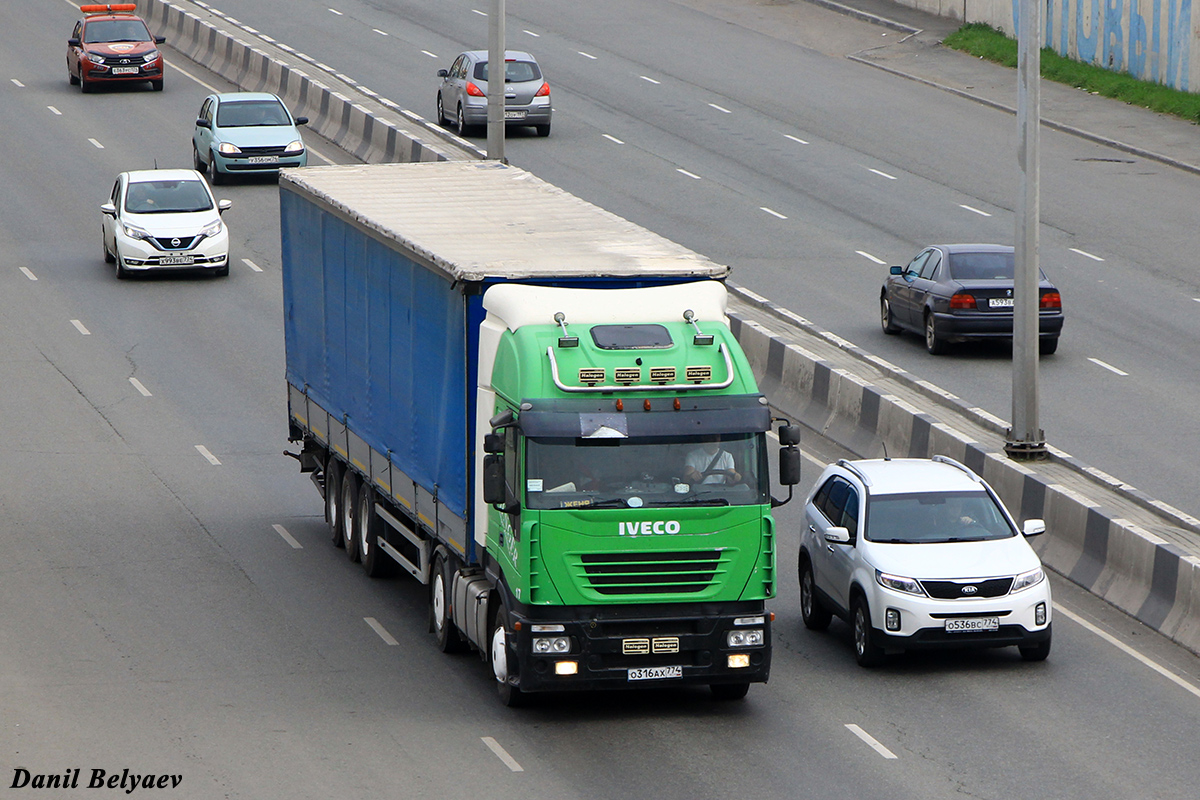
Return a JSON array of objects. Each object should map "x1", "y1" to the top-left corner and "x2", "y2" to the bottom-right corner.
[{"x1": 580, "y1": 551, "x2": 722, "y2": 595}]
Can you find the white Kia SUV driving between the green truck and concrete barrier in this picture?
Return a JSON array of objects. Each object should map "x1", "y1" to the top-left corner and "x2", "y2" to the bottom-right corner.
[{"x1": 798, "y1": 456, "x2": 1051, "y2": 667}]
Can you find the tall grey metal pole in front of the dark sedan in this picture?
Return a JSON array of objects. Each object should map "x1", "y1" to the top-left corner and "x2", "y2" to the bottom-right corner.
[{"x1": 1004, "y1": 0, "x2": 1045, "y2": 459}]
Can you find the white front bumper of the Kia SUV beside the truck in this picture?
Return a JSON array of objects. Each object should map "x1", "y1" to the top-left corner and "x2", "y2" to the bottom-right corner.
[{"x1": 871, "y1": 581, "x2": 1052, "y2": 650}]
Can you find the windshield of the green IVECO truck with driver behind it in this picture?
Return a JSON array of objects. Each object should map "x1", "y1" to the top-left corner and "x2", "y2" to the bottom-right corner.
[{"x1": 526, "y1": 433, "x2": 769, "y2": 509}]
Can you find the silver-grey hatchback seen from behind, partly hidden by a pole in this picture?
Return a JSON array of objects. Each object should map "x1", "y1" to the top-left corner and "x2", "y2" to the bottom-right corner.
[{"x1": 438, "y1": 50, "x2": 553, "y2": 136}]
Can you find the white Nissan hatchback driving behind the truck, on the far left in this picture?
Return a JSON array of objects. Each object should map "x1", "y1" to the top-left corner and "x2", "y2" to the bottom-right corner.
[{"x1": 100, "y1": 169, "x2": 232, "y2": 278}]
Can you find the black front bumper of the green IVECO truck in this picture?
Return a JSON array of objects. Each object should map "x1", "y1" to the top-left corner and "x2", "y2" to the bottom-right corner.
[{"x1": 510, "y1": 601, "x2": 770, "y2": 692}]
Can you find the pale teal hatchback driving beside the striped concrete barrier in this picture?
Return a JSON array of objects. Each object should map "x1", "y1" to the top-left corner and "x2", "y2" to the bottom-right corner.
[{"x1": 192, "y1": 91, "x2": 308, "y2": 184}]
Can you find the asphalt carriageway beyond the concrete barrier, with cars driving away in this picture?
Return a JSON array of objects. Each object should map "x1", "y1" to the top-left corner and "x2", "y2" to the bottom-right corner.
[{"x1": 189, "y1": 0, "x2": 1200, "y2": 525}]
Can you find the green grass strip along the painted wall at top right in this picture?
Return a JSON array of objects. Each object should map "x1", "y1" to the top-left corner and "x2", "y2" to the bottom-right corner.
[{"x1": 942, "y1": 23, "x2": 1200, "y2": 122}]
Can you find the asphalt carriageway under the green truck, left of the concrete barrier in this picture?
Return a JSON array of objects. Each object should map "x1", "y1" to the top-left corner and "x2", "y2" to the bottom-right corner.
[{"x1": 0, "y1": 2, "x2": 1200, "y2": 800}]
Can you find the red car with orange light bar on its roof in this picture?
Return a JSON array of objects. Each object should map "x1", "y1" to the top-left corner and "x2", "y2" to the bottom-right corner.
[{"x1": 67, "y1": 2, "x2": 167, "y2": 92}]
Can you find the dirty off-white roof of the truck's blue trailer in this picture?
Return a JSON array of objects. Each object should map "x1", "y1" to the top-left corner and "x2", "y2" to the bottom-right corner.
[{"x1": 280, "y1": 161, "x2": 730, "y2": 281}]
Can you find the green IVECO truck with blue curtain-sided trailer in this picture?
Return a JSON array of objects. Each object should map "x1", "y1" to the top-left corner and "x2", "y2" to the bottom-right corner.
[{"x1": 280, "y1": 162, "x2": 799, "y2": 704}]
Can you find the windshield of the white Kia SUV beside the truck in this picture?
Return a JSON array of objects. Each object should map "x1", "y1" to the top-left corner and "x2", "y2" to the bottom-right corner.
[{"x1": 866, "y1": 492, "x2": 1016, "y2": 545}]
